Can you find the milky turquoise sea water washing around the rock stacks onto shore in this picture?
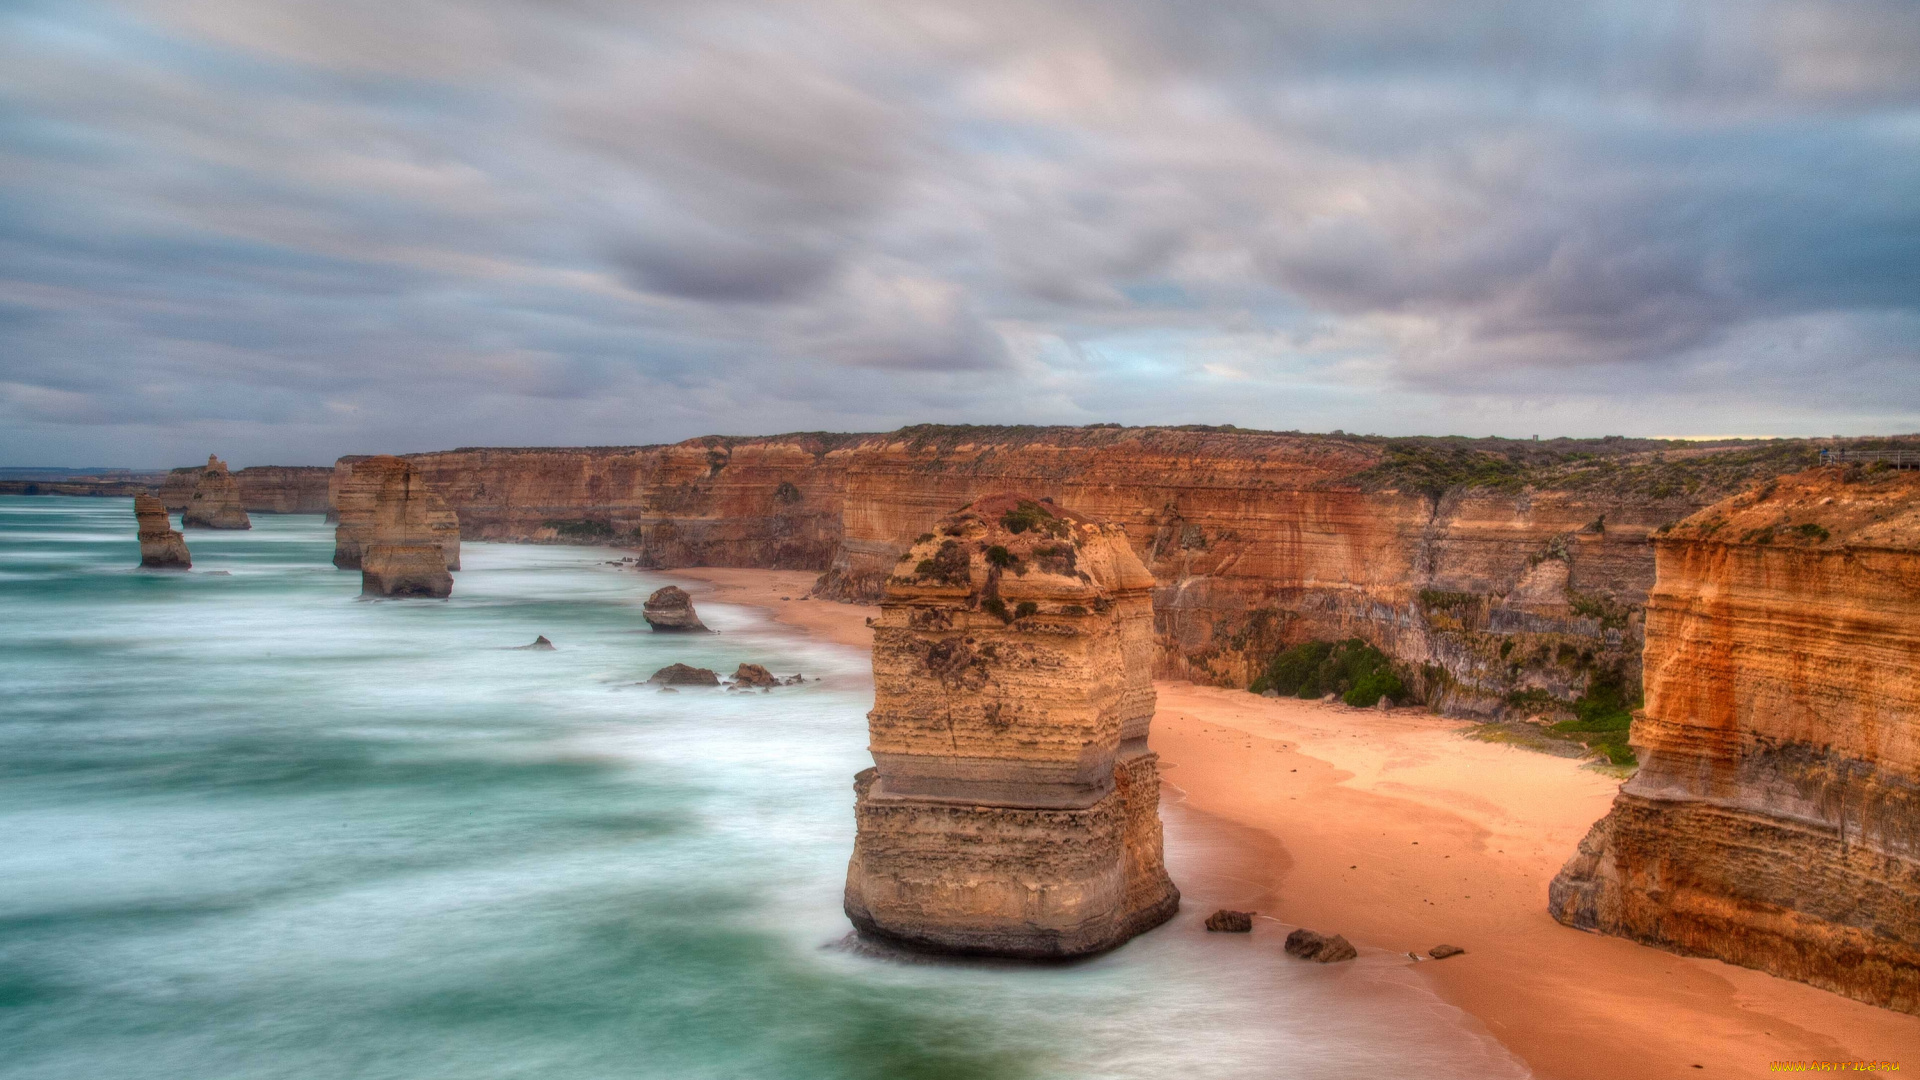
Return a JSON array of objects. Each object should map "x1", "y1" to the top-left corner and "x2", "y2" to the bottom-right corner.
[{"x1": 0, "y1": 498, "x2": 1524, "y2": 1080}]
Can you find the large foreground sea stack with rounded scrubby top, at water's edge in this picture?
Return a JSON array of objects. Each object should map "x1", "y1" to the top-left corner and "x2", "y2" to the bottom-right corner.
[{"x1": 847, "y1": 494, "x2": 1179, "y2": 959}]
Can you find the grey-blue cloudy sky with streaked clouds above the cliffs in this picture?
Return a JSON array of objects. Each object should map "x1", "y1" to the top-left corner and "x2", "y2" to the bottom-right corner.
[{"x1": 0, "y1": 0, "x2": 1920, "y2": 467}]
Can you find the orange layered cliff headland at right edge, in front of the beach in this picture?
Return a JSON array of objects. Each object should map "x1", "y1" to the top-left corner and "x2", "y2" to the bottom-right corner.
[{"x1": 1548, "y1": 467, "x2": 1920, "y2": 1013}]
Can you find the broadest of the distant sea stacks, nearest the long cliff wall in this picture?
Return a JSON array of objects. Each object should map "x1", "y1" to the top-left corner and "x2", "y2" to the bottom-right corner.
[{"x1": 357, "y1": 457, "x2": 459, "y2": 598}]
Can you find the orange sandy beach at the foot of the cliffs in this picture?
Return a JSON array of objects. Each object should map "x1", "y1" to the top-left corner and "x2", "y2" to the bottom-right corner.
[{"x1": 672, "y1": 569, "x2": 1920, "y2": 1080}]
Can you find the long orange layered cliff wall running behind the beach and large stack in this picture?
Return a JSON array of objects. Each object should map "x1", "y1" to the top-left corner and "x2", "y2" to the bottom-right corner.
[{"x1": 342, "y1": 427, "x2": 1811, "y2": 715}]
